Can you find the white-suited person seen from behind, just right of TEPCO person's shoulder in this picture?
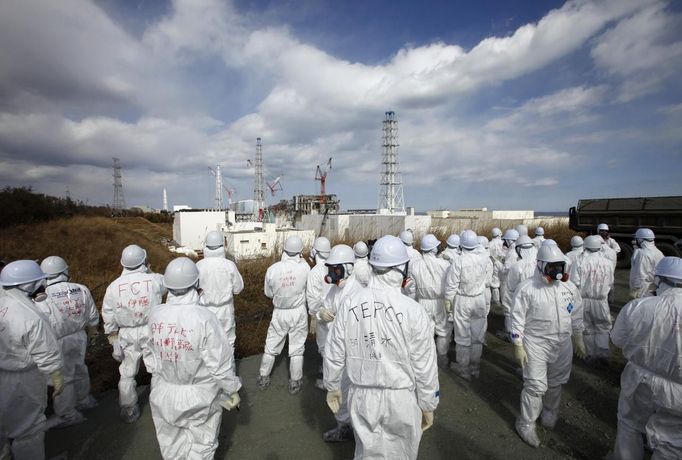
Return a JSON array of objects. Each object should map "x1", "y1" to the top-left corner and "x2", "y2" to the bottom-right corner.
[{"x1": 410, "y1": 233, "x2": 452, "y2": 369}]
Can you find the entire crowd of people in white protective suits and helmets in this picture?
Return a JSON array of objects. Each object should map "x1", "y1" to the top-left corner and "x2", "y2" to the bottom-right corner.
[{"x1": 0, "y1": 224, "x2": 682, "y2": 459}]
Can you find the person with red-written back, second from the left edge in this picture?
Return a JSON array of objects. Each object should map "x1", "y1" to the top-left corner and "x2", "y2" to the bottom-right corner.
[{"x1": 36, "y1": 256, "x2": 99, "y2": 428}]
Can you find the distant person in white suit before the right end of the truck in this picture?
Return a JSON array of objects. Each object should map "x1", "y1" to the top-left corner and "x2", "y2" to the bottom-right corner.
[{"x1": 630, "y1": 228, "x2": 663, "y2": 299}]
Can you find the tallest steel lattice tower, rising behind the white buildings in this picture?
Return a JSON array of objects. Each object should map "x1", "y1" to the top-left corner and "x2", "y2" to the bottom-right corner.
[{"x1": 379, "y1": 112, "x2": 405, "y2": 214}]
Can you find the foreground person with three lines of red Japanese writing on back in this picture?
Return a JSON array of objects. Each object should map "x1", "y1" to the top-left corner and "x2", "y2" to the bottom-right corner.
[{"x1": 144, "y1": 257, "x2": 241, "y2": 460}]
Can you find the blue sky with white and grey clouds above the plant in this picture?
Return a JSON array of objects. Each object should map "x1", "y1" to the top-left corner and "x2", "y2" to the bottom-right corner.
[{"x1": 0, "y1": 0, "x2": 682, "y2": 211}]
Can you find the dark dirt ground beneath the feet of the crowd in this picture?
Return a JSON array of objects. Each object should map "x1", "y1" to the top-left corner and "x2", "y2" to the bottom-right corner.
[{"x1": 46, "y1": 270, "x2": 628, "y2": 460}]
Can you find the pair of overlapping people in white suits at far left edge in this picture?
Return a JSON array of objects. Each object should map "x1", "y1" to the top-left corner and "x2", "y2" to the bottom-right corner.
[{"x1": 0, "y1": 256, "x2": 99, "y2": 460}]
